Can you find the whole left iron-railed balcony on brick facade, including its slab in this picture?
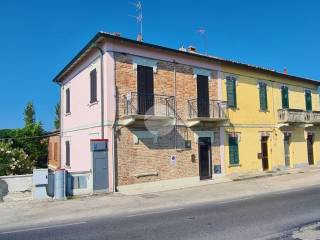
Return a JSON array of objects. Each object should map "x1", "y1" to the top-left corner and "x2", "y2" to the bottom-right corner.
[{"x1": 121, "y1": 92, "x2": 175, "y2": 126}]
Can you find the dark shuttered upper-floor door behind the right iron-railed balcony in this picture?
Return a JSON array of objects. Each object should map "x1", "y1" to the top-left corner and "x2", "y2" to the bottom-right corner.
[{"x1": 197, "y1": 75, "x2": 209, "y2": 117}]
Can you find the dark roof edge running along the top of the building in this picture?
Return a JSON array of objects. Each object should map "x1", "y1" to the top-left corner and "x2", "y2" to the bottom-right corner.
[{"x1": 53, "y1": 32, "x2": 320, "y2": 85}]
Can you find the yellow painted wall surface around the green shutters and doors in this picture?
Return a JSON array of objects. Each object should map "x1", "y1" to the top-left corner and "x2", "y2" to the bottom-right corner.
[{"x1": 221, "y1": 66, "x2": 320, "y2": 174}]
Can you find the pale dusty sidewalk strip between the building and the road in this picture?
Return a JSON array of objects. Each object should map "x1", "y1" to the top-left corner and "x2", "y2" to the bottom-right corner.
[{"x1": 0, "y1": 169, "x2": 320, "y2": 230}]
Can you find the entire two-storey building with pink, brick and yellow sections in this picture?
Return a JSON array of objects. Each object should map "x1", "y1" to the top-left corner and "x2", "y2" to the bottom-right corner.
[{"x1": 54, "y1": 33, "x2": 320, "y2": 194}]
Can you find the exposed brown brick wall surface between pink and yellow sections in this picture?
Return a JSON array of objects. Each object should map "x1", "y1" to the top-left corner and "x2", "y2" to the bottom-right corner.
[{"x1": 115, "y1": 53, "x2": 220, "y2": 185}]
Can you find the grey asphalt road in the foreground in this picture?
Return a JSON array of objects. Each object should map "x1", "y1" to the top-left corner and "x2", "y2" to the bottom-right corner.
[{"x1": 0, "y1": 187, "x2": 320, "y2": 240}]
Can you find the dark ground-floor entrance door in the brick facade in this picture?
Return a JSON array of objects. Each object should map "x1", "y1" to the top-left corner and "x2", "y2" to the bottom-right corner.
[{"x1": 199, "y1": 137, "x2": 212, "y2": 180}]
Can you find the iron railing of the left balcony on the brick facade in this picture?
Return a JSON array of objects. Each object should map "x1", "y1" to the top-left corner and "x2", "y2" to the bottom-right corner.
[{"x1": 124, "y1": 92, "x2": 175, "y2": 117}]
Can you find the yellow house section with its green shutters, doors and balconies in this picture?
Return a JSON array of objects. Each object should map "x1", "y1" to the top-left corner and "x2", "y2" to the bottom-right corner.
[{"x1": 221, "y1": 64, "x2": 320, "y2": 174}]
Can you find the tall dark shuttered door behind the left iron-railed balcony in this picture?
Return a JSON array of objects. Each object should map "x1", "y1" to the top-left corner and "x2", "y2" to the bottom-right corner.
[{"x1": 137, "y1": 65, "x2": 154, "y2": 115}]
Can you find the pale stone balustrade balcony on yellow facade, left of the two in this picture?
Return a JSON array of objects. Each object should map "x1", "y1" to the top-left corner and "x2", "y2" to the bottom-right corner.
[{"x1": 278, "y1": 109, "x2": 308, "y2": 125}]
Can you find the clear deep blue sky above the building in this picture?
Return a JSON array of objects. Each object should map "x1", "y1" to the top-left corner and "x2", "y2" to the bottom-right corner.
[{"x1": 0, "y1": 0, "x2": 320, "y2": 130}]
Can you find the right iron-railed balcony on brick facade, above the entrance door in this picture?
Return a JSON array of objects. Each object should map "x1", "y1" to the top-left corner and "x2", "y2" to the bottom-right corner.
[{"x1": 188, "y1": 99, "x2": 228, "y2": 127}]
